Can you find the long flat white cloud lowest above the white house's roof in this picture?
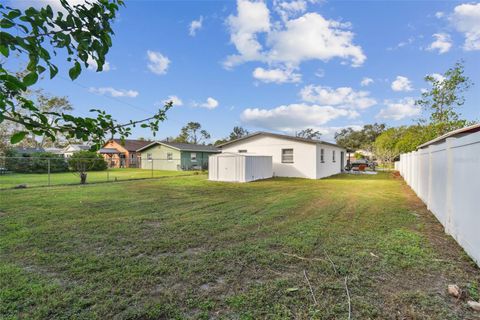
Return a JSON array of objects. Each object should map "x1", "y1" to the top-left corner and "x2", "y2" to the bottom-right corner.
[{"x1": 241, "y1": 103, "x2": 359, "y2": 132}]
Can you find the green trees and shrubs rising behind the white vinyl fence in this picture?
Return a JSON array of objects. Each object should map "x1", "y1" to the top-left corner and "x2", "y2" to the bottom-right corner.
[{"x1": 335, "y1": 61, "x2": 475, "y2": 164}]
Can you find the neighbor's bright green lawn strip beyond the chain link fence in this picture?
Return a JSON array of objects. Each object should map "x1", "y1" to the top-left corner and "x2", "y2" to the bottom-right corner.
[{"x1": 0, "y1": 168, "x2": 196, "y2": 189}]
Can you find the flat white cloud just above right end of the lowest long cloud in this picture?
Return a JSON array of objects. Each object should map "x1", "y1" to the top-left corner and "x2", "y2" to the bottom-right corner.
[{"x1": 300, "y1": 85, "x2": 377, "y2": 109}]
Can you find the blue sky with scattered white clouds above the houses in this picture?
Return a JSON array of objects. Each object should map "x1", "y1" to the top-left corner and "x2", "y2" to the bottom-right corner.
[{"x1": 11, "y1": 0, "x2": 480, "y2": 142}]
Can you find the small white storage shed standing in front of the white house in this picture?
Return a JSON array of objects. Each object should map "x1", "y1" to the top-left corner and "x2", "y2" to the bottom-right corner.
[{"x1": 208, "y1": 153, "x2": 273, "y2": 182}]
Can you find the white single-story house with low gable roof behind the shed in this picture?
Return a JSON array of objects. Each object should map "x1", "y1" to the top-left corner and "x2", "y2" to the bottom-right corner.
[{"x1": 218, "y1": 132, "x2": 346, "y2": 179}]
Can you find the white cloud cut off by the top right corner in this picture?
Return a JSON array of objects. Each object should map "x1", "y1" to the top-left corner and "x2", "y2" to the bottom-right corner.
[{"x1": 450, "y1": 3, "x2": 480, "y2": 51}]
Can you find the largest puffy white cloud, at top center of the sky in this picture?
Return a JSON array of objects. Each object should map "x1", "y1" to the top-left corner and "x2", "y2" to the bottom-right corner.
[{"x1": 224, "y1": 0, "x2": 366, "y2": 68}]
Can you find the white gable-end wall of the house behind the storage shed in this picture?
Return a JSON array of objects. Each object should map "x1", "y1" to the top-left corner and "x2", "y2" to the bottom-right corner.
[{"x1": 222, "y1": 135, "x2": 318, "y2": 179}]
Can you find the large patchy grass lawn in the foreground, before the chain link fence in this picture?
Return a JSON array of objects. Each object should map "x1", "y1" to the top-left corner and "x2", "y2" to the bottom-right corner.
[{"x1": 0, "y1": 173, "x2": 480, "y2": 319}]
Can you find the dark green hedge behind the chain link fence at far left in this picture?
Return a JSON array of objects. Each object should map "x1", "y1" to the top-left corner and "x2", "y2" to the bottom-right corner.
[{"x1": 5, "y1": 150, "x2": 68, "y2": 173}]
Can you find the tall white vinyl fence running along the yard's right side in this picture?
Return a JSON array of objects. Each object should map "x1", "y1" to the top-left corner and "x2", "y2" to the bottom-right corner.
[{"x1": 395, "y1": 132, "x2": 480, "y2": 265}]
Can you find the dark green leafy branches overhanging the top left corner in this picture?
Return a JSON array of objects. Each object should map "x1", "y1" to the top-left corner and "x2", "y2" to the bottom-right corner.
[{"x1": 0, "y1": 0, "x2": 172, "y2": 146}]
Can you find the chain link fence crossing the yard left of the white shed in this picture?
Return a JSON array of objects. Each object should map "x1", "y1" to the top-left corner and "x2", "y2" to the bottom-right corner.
[{"x1": 0, "y1": 157, "x2": 201, "y2": 189}]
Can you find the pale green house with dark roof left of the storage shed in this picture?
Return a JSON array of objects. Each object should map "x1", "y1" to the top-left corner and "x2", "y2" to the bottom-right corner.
[{"x1": 137, "y1": 141, "x2": 220, "y2": 170}]
